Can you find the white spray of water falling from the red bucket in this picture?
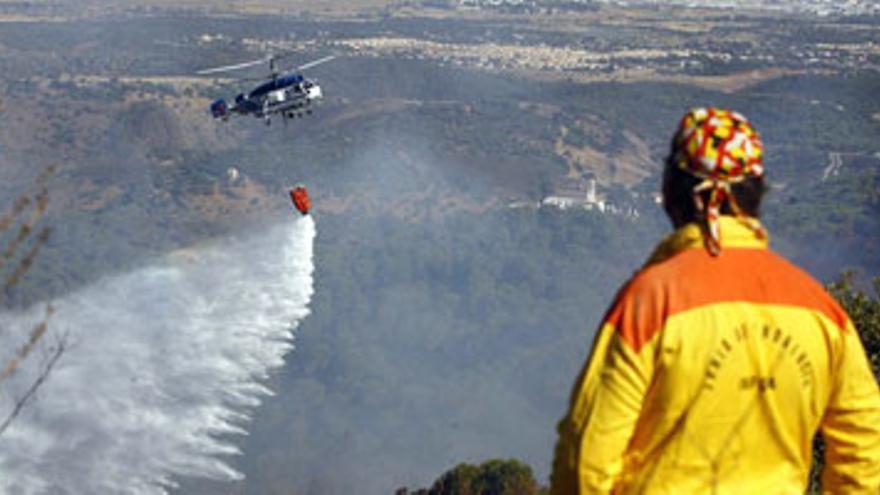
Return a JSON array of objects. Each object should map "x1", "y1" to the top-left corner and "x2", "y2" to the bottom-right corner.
[{"x1": 0, "y1": 217, "x2": 315, "y2": 494}]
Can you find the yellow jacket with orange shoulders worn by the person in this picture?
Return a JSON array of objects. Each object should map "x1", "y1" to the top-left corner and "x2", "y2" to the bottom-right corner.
[{"x1": 551, "y1": 217, "x2": 880, "y2": 495}]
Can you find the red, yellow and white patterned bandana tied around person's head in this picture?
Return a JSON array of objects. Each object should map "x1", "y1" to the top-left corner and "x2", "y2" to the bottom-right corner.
[{"x1": 672, "y1": 108, "x2": 766, "y2": 256}]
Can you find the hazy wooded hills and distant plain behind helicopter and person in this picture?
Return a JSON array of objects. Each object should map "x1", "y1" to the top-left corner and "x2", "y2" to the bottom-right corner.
[{"x1": 0, "y1": 0, "x2": 880, "y2": 494}]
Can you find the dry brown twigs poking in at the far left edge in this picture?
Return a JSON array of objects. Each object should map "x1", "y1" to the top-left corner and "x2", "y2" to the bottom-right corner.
[{"x1": 0, "y1": 102, "x2": 66, "y2": 436}]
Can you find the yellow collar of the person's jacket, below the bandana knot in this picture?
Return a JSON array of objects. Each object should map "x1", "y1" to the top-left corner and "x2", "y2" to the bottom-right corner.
[{"x1": 645, "y1": 215, "x2": 770, "y2": 266}]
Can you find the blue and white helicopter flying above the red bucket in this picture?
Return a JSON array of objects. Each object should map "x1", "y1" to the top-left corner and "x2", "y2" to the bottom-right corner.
[{"x1": 196, "y1": 55, "x2": 336, "y2": 125}]
